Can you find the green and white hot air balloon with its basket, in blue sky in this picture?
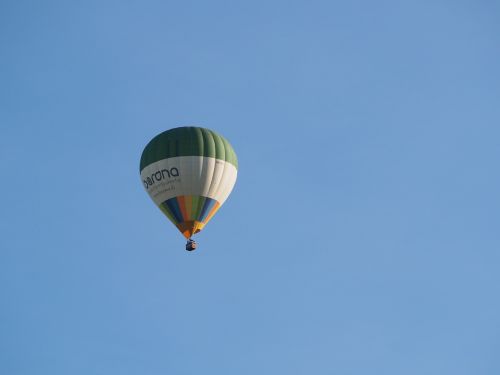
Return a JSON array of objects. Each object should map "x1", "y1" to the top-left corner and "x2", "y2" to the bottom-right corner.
[{"x1": 140, "y1": 126, "x2": 238, "y2": 251}]
